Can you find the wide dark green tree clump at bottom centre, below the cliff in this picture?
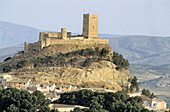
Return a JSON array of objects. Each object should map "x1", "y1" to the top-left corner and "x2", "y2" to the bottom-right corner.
[{"x1": 59, "y1": 90, "x2": 152, "y2": 112}]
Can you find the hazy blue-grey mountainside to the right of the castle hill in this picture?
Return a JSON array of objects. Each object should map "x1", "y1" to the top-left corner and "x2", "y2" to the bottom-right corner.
[{"x1": 102, "y1": 36, "x2": 170, "y2": 65}]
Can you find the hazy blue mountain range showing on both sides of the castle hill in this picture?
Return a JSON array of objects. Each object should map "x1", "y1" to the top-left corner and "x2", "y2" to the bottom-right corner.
[{"x1": 0, "y1": 21, "x2": 170, "y2": 65}]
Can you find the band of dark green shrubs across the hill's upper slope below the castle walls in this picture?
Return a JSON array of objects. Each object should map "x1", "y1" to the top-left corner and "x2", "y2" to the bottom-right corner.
[{"x1": 3, "y1": 47, "x2": 129, "y2": 72}]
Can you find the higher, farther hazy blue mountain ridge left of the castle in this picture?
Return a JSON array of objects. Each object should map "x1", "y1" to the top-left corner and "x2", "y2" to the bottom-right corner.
[{"x1": 0, "y1": 21, "x2": 40, "y2": 48}]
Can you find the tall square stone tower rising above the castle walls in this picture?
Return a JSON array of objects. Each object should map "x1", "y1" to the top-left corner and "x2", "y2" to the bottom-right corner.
[{"x1": 83, "y1": 14, "x2": 98, "y2": 39}]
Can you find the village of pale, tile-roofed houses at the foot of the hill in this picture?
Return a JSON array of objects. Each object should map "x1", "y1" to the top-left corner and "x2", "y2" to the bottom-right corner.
[{"x1": 0, "y1": 73, "x2": 167, "y2": 112}]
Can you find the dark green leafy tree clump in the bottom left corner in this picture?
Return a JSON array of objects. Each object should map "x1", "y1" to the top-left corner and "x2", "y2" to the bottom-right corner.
[{"x1": 0, "y1": 88, "x2": 37, "y2": 112}]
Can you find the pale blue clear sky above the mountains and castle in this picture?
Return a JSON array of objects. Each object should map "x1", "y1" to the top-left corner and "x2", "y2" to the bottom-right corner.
[{"x1": 0, "y1": 0, "x2": 170, "y2": 36}]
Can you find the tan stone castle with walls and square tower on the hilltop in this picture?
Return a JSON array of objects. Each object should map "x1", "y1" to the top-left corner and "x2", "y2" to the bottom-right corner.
[{"x1": 24, "y1": 14, "x2": 108, "y2": 52}]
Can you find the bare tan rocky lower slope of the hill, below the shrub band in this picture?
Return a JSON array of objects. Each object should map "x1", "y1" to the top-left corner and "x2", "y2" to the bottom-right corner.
[{"x1": 5, "y1": 61, "x2": 130, "y2": 90}]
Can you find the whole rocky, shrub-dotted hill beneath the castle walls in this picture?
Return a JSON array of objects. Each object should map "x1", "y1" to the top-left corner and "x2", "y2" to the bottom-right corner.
[{"x1": 0, "y1": 44, "x2": 131, "y2": 90}]
